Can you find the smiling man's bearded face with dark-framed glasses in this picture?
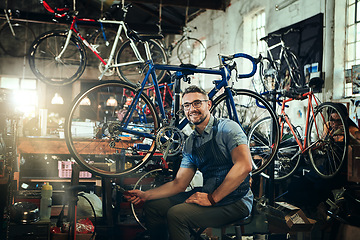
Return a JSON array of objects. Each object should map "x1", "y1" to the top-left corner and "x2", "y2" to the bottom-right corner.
[{"x1": 182, "y1": 92, "x2": 211, "y2": 125}]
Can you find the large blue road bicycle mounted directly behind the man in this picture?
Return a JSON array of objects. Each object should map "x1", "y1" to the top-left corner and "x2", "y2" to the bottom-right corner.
[{"x1": 65, "y1": 53, "x2": 279, "y2": 177}]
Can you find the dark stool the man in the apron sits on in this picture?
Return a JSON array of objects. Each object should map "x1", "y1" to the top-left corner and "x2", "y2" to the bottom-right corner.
[{"x1": 192, "y1": 214, "x2": 252, "y2": 240}]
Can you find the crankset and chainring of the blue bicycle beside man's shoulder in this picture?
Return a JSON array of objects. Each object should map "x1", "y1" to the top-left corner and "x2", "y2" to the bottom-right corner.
[{"x1": 156, "y1": 126, "x2": 184, "y2": 158}]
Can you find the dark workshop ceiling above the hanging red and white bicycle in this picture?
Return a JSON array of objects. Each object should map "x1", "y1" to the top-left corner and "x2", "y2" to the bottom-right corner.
[{"x1": 0, "y1": 0, "x2": 230, "y2": 34}]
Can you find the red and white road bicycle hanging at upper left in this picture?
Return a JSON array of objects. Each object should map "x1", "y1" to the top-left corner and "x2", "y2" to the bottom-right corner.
[{"x1": 29, "y1": 0, "x2": 167, "y2": 86}]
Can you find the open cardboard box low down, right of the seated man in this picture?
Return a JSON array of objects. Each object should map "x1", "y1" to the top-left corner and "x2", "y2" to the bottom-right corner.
[{"x1": 266, "y1": 202, "x2": 316, "y2": 233}]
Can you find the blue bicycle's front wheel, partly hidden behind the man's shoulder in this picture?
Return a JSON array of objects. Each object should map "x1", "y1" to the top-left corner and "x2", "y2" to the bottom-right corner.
[{"x1": 211, "y1": 89, "x2": 280, "y2": 174}]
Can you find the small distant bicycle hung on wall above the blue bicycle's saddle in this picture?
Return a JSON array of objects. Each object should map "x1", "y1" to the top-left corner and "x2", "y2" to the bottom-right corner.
[{"x1": 165, "y1": 26, "x2": 206, "y2": 66}]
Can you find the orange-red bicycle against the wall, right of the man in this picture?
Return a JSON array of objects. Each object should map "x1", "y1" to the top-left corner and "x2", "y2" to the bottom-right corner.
[{"x1": 249, "y1": 81, "x2": 349, "y2": 180}]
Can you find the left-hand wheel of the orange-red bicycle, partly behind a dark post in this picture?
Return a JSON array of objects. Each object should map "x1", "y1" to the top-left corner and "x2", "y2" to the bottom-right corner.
[{"x1": 249, "y1": 117, "x2": 301, "y2": 180}]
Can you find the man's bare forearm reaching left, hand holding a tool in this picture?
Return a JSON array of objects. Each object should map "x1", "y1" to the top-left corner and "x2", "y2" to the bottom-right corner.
[{"x1": 125, "y1": 167, "x2": 195, "y2": 204}]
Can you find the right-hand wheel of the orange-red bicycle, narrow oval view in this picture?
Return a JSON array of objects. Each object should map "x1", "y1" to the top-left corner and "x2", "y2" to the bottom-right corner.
[{"x1": 307, "y1": 103, "x2": 349, "y2": 178}]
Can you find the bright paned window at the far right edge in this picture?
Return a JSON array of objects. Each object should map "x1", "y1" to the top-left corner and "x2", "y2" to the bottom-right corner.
[{"x1": 345, "y1": 0, "x2": 360, "y2": 96}]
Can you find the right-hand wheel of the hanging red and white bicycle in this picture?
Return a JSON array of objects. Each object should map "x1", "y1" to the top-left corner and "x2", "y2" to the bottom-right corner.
[{"x1": 116, "y1": 40, "x2": 167, "y2": 85}]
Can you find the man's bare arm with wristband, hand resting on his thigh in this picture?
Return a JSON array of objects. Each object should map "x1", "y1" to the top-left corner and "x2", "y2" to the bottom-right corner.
[{"x1": 186, "y1": 144, "x2": 252, "y2": 206}]
